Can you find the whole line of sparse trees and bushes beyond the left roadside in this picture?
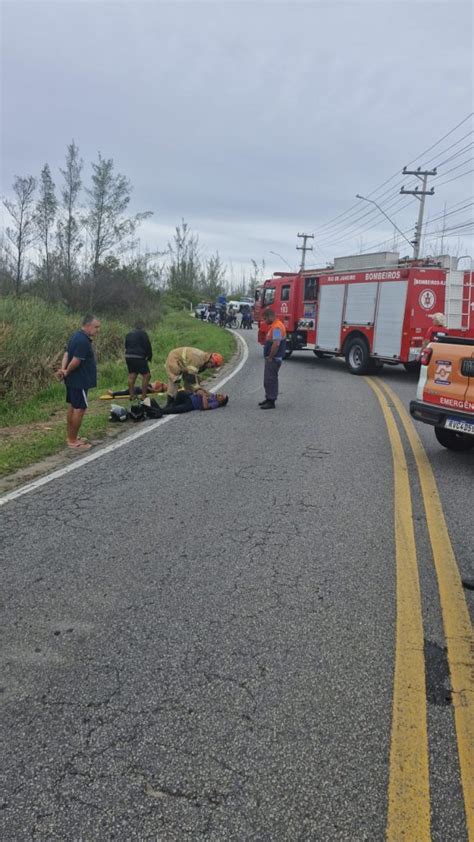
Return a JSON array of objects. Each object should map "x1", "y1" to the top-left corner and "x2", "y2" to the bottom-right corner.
[{"x1": 0, "y1": 141, "x2": 264, "y2": 315}]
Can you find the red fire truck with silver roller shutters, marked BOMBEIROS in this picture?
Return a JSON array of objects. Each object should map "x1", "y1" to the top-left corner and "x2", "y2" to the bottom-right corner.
[{"x1": 256, "y1": 246, "x2": 474, "y2": 374}]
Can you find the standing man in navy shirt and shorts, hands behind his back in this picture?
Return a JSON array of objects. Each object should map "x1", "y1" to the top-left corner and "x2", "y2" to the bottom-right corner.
[{"x1": 57, "y1": 315, "x2": 100, "y2": 450}]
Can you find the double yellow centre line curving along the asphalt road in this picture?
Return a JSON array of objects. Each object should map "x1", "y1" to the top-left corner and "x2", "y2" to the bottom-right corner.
[{"x1": 366, "y1": 378, "x2": 474, "y2": 842}]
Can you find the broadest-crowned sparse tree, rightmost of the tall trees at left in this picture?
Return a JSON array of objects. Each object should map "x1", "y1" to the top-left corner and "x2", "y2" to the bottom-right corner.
[{"x1": 83, "y1": 152, "x2": 152, "y2": 278}]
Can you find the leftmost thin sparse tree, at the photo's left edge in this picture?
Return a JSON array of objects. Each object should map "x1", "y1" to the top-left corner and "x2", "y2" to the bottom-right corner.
[{"x1": 3, "y1": 175, "x2": 36, "y2": 295}]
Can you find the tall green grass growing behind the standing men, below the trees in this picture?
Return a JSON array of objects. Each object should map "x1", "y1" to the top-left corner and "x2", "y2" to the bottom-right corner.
[{"x1": 0, "y1": 297, "x2": 235, "y2": 430}]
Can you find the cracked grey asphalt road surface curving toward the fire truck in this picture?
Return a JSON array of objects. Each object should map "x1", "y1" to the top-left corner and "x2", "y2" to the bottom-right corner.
[{"x1": 0, "y1": 334, "x2": 474, "y2": 842}]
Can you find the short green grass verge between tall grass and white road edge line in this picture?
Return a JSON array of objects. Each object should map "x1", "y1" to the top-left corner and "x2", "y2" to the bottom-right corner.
[{"x1": 0, "y1": 313, "x2": 235, "y2": 476}]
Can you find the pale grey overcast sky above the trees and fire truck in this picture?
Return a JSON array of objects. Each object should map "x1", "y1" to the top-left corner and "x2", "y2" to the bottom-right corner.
[{"x1": 1, "y1": 0, "x2": 474, "y2": 275}]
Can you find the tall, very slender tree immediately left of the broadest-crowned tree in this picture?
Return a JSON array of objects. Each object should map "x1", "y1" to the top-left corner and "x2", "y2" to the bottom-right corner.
[{"x1": 58, "y1": 141, "x2": 83, "y2": 287}]
